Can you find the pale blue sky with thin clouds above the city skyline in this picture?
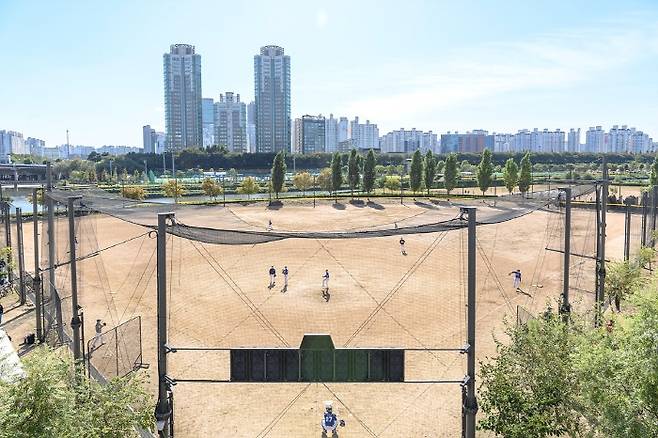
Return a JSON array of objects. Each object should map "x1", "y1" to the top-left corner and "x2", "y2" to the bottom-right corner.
[{"x1": 0, "y1": 0, "x2": 658, "y2": 146}]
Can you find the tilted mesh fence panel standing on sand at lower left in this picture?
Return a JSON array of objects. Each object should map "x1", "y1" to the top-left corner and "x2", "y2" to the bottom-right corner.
[{"x1": 87, "y1": 316, "x2": 143, "y2": 380}]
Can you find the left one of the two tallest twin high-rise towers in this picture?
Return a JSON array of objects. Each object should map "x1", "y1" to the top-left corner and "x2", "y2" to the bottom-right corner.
[{"x1": 163, "y1": 44, "x2": 203, "y2": 150}]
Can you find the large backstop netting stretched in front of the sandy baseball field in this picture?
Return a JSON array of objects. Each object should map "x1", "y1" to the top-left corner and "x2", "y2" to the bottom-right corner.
[{"x1": 41, "y1": 186, "x2": 591, "y2": 436}]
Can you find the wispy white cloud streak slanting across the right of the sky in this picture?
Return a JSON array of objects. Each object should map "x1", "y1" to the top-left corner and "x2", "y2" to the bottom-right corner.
[{"x1": 345, "y1": 16, "x2": 658, "y2": 130}]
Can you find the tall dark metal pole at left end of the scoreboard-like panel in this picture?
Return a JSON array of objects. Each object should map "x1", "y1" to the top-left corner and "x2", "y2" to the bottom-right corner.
[{"x1": 155, "y1": 213, "x2": 174, "y2": 437}]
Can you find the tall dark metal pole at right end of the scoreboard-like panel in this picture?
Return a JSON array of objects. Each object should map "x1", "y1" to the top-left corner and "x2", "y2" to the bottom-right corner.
[{"x1": 462, "y1": 207, "x2": 478, "y2": 438}]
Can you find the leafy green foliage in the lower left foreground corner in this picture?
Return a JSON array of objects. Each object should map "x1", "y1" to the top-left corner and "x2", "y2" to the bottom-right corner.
[{"x1": 0, "y1": 347, "x2": 153, "y2": 438}]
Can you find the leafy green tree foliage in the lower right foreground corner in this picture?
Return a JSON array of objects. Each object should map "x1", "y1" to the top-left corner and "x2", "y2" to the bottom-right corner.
[{"x1": 480, "y1": 284, "x2": 658, "y2": 438}]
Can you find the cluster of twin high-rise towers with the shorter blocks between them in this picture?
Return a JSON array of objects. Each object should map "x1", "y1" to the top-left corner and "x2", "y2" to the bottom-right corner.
[{"x1": 158, "y1": 44, "x2": 292, "y2": 153}]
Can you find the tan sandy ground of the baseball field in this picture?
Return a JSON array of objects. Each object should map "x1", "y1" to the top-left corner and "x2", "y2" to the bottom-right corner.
[{"x1": 6, "y1": 200, "x2": 639, "y2": 437}]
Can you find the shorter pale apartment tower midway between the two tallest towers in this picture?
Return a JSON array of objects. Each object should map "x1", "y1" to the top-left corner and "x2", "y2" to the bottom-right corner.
[{"x1": 215, "y1": 91, "x2": 248, "y2": 153}]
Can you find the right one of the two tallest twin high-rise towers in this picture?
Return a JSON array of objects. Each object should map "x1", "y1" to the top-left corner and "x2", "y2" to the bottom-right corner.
[{"x1": 254, "y1": 46, "x2": 291, "y2": 152}]
